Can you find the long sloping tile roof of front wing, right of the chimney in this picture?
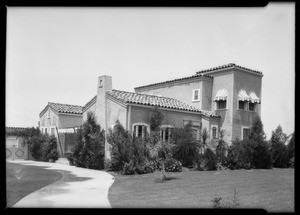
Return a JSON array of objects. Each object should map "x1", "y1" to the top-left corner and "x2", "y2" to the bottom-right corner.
[{"x1": 106, "y1": 90, "x2": 220, "y2": 117}]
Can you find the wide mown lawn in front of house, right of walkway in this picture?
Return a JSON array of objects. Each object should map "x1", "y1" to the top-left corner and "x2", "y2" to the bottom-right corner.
[{"x1": 108, "y1": 169, "x2": 294, "y2": 212}]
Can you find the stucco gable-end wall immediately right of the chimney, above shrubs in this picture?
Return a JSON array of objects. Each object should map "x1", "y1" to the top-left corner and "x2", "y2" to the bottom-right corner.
[{"x1": 106, "y1": 99, "x2": 127, "y2": 131}]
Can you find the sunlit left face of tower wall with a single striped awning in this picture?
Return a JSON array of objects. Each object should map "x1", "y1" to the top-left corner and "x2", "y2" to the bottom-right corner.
[{"x1": 210, "y1": 70, "x2": 234, "y2": 145}]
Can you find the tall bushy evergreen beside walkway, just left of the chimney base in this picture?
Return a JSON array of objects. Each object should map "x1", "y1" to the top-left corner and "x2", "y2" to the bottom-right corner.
[{"x1": 72, "y1": 112, "x2": 105, "y2": 169}]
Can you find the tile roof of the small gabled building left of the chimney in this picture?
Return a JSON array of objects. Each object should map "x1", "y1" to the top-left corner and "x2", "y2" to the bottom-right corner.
[{"x1": 40, "y1": 102, "x2": 82, "y2": 117}]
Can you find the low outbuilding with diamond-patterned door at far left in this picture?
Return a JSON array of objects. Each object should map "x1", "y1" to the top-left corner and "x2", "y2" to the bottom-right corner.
[{"x1": 5, "y1": 127, "x2": 32, "y2": 160}]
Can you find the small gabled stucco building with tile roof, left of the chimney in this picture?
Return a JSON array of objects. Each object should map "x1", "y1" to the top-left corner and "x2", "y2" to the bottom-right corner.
[{"x1": 39, "y1": 102, "x2": 82, "y2": 137}]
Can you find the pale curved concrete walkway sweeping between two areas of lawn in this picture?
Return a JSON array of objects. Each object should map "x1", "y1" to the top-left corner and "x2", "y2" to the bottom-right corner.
[{"x1": 10, "y1": 160, "x2": 114, "y2": 208}]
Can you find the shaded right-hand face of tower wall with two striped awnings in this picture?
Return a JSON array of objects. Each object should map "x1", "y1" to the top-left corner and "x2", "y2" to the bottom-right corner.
[{"x1": 232, "y1": 70, "x2": 262, "y2": 139}]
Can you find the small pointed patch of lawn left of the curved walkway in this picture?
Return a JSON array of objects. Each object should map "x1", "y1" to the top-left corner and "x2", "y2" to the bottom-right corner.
[{"x1": 6, "y1": 162, "x2": 63, "y2": 207}]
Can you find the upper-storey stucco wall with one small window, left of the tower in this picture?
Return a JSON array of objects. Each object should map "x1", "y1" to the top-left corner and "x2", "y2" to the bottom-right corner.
[{"x1": 135, "y1": 76, "x2": 212, "y2": 110}]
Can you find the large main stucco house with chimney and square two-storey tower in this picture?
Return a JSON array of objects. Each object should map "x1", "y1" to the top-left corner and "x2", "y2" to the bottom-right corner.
[{"x1": 82, "y1": 63, "x2": 263, "y2": 158}]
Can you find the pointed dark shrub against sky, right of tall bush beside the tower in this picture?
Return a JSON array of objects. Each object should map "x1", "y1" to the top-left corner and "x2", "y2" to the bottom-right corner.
[{"x1": 270, "y1": 125, "x2": 290, "y2": 168}]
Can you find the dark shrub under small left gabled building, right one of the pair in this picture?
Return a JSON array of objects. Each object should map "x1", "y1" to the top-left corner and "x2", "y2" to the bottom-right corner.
[{"x1": 42, "y1": 136, "x2": 58, "y2": 162}]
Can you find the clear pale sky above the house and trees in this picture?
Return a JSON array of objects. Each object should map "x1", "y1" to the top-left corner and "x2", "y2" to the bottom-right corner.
[{"x1": 5, "y1": 3, "x2": 295, "y2": 138}]
